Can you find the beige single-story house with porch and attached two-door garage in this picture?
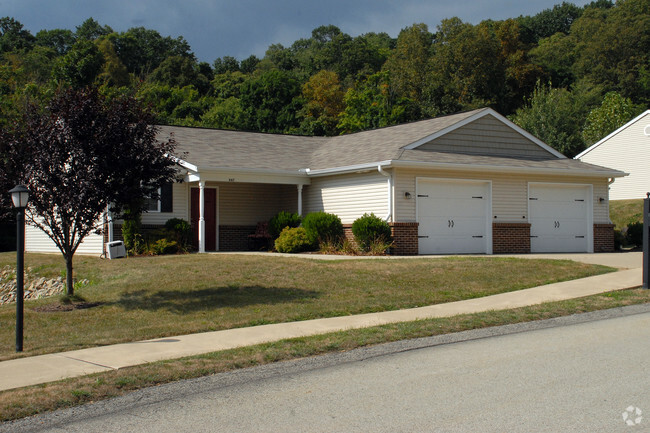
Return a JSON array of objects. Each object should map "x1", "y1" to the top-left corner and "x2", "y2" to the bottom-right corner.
[{"x1": 27, "y1": 108, "x2": 625, "y2": 255}]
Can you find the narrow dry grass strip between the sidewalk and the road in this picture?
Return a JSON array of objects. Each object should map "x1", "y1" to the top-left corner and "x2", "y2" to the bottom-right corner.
[{"x1": 0, "y1": 289, "x2": 650, "y2": 421}]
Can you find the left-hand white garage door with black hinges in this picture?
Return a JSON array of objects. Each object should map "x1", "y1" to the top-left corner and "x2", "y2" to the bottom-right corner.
[{"x1": 417, "y1": 179, "x2": 492, "y2": 254}]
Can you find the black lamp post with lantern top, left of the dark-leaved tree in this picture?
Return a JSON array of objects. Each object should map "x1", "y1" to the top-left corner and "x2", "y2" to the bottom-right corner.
[{"x1": 9, "y1": 185, "x2": 29, "y2": 352}]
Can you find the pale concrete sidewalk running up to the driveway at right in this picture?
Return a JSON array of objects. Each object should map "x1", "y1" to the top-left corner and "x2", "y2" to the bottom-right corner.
[{"x1": 0, "y1": 253, "x2": 642, "y2": 391}]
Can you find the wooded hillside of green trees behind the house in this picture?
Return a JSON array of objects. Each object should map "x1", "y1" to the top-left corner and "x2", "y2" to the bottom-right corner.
[{"x1": 0, "y1": 0, "x2": 650, "y2": 156}]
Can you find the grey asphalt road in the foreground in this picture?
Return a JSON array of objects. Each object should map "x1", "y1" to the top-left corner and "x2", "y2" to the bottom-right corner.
[{"x1": 5, "y1": 304, "x2": 650, "y2": 433}]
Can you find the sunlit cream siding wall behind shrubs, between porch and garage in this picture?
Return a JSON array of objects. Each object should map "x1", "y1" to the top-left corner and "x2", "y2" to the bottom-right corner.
[{"x1": 303, "y1": 172, "x2": 388, "y2": 224}]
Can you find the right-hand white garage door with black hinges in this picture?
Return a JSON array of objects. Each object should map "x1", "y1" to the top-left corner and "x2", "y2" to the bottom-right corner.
[{"x1": 528, "y1": 184, "x2": 593, "y2": 253}]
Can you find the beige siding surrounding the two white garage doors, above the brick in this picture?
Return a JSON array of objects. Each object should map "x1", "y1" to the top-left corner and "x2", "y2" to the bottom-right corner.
[{"x1": 395, "y1": 169, "x2": 609, "y2": 224}]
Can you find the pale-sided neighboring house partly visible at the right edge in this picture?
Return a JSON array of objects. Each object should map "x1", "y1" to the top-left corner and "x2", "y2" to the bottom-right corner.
[{"x1": 576, "y1": 110, "x2": 650, "y2": 200}]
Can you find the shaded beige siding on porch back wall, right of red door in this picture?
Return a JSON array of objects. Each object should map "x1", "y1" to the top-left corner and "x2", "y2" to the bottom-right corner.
[{"x1": 206, "y1": 182, "x2": 298, "y2": 225}]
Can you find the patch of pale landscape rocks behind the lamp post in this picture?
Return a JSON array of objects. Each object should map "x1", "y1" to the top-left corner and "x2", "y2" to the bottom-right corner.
[{"x1": 0, "y1": 266, "x2": 88, "y2": 305}]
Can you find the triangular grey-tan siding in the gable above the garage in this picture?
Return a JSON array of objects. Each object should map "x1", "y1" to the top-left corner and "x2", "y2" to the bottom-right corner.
[{"x1": 418, "y1": 115, "x2": 556, "y2": 160}]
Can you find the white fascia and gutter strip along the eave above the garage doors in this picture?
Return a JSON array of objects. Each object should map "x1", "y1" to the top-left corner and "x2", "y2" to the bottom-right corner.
[{"x1": 392, "y1": 161, "x2": 629, "y2": 178}]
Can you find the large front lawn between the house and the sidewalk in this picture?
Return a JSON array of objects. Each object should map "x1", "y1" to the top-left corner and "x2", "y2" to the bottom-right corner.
[{"x1": 0, "y1": 253, "x2": 612, "y2": 359}]
